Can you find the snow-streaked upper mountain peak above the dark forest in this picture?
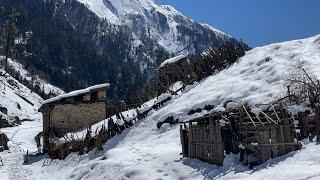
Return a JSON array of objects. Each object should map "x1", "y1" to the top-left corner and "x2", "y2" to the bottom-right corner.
[{"x1": 63, "y1": 0, "x2": 245, "y2": 71}]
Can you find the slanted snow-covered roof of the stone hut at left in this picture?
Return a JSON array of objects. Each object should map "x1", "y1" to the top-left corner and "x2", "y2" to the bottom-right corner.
[{"x1": 42, "y1": 83, "x2": 110, "y2": 105}]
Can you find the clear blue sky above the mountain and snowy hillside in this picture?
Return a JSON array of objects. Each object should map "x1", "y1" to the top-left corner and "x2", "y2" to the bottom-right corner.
[{"x1": 155, "y1": 0, "x2": 320, "y2": 47}]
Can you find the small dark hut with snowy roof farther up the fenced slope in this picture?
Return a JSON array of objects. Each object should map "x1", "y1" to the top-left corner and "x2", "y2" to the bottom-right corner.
[{"x1": 157, "y1": 55, "x2": 196, "y2": 90}]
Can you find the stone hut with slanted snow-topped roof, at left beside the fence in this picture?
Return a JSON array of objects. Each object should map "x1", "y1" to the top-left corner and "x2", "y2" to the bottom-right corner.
[{"x1": 39, "y1": 83, "x2": 110, "y2": 136}]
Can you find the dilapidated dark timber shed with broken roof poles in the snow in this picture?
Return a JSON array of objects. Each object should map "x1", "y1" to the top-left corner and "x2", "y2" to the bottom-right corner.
[{"x1": 180, "y1": 105, "x2": 301, "y2": 167}]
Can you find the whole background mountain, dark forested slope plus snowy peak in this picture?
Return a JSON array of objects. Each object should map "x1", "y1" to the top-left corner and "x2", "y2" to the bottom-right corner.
[{"x1": 0, "y1": 0, "x2": 248, "y2": 100}]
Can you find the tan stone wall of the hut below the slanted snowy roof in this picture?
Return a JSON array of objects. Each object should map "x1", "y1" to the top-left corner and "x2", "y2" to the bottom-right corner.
[{"x1": 49, "y1": 102, "x2": 106, "y2": 132}]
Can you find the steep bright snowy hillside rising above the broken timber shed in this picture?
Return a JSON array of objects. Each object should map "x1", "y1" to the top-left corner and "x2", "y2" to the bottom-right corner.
[{"x1": 153, "y1": 35, "x2": 320, "y2": 121}]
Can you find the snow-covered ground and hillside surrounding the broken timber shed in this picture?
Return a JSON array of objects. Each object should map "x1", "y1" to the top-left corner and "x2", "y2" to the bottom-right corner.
[{"x1": 0, "y1": 35, "x2": 320, "y2": 180}]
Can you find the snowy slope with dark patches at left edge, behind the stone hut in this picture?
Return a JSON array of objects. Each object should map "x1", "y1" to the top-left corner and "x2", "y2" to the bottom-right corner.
[{"x1": 0, "y1": 56, "x2": 64, "y2": 121}]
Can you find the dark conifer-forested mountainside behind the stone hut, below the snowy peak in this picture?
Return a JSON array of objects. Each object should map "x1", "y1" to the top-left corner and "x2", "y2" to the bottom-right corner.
[{"x1": 0, "y1": 0, "x2": 146, "y2": 99}]
